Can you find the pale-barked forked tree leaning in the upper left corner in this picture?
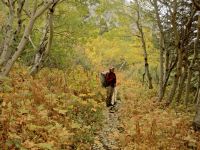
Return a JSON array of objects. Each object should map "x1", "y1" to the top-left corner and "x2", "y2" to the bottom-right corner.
[{"x1": 0, "y1": 0, "x2": 59, "y2": 76}]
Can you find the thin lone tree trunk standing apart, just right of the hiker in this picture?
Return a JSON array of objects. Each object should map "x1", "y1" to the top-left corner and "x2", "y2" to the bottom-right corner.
[{"x1": 136, "y1": 0, "x2": 153, "y2": 89}]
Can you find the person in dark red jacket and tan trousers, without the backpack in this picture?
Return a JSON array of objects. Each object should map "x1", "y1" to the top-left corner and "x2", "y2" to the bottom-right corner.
[{"x1": 106, "y1": 67, "x2": 116, "y2": 107}]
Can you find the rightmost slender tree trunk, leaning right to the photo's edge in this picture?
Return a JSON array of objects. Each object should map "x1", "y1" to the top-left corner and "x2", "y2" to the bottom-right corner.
[{"x1": 184, "y1": 16, "x2": 200, "y2": 106}]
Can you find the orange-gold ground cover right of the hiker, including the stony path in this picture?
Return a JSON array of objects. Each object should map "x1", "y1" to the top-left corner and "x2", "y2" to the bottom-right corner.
[{"x1": 93, "y1": 80, "x2": 200, "y2": 150}]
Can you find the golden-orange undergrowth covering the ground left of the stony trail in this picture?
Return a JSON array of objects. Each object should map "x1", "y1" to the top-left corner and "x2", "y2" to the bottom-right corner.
[{"x1": 0, "y1": 67, "x2": 104, "y2": 150}]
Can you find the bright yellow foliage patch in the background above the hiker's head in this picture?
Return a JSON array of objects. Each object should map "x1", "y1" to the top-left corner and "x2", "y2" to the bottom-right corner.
[{"x1": 85, "y1": 29, "x2": 159, "y2": 69}]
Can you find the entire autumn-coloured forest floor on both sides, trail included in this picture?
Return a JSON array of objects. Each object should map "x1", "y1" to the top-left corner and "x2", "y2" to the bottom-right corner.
[{"x1": 0, "y1": 68, "x2": 200, "y2": 150}]
